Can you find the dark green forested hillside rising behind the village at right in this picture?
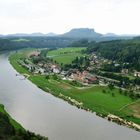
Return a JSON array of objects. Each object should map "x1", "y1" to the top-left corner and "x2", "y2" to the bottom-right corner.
[{"x1": 87, "y1": 39, "x2": 140, "y2": 70}]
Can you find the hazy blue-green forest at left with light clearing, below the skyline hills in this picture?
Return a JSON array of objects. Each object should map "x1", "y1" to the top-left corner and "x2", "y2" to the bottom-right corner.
[{"x1": 0, "y1": 37, "x2": 75, "y2": 51}]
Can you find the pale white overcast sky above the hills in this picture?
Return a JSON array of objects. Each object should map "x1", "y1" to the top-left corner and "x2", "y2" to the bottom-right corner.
[{"x1": 0, "y1": 0, "x2": 140, "y2": 34}]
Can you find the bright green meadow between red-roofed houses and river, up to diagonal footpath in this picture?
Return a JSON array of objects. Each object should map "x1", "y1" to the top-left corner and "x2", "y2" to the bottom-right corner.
[{"x1": 29, "y1": 75, "x2": 136, "y2": 117}]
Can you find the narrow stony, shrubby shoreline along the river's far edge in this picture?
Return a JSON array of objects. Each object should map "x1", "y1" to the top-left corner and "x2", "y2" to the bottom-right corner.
[{"x1": 8, "y1": 52, "x2": 140, "y2": 132}]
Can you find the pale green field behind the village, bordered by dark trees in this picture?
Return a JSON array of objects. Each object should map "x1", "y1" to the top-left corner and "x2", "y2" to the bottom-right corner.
[{"x1": 47, "y1": 48, "x2": 85, "y2": 64}]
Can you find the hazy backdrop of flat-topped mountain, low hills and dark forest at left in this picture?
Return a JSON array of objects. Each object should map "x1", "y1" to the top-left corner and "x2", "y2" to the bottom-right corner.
[{"x1": 0, "y1": 28, "x2": 133, "y2": 51}]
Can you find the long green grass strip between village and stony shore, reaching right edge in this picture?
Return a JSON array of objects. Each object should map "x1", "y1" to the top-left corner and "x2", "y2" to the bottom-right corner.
[{"x1": 10, "y1": 49, "x2": 140, "y2": 124}]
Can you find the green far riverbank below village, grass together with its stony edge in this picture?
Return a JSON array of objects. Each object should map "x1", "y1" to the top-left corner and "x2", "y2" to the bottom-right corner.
[{"x1": 10, "y1": 50, "x2": 140, "y2": 130}]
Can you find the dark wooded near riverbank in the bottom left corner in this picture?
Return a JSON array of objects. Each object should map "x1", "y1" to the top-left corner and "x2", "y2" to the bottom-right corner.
[{"x1": 0, "y1": 104, "x2": 48, "y2": 140}]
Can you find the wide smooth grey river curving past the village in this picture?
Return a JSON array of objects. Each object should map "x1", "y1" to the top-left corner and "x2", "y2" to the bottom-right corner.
[{"x1": 0, "y1": 54, "x2": 140, "y2": 140}]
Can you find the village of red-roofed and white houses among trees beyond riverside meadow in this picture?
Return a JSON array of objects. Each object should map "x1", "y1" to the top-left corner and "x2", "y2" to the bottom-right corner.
[{"x1": 19, "y1": 50, "x2": 140, "y2": 91}]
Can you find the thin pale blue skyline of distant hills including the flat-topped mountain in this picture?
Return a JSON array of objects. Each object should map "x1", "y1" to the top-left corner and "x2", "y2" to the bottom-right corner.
[{"x1": 0, "y1": 28, "x2": 136, "y2": 42}]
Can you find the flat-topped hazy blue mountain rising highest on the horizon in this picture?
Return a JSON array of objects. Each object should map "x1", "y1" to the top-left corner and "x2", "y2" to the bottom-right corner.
[{"x1": 61, "y1": 28, "x2": 102, "y2": 39}]
